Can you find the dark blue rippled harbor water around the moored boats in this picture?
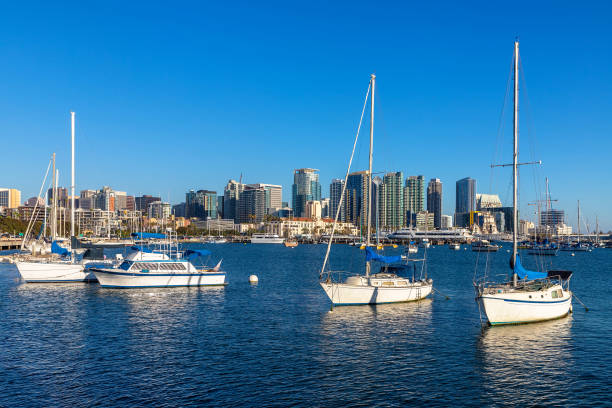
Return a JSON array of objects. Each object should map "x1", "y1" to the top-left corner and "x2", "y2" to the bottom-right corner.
[{"x1": 0, "y1": 244, "x2": 612, "y2": 407}]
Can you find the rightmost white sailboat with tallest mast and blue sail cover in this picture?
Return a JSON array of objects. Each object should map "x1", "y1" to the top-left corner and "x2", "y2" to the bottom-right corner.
[{"x1": 474, "y1": 41, "x2": 572, "y2": 326}]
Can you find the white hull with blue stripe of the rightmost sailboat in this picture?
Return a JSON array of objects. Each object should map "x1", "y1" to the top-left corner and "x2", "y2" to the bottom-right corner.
[{"x1": 478, "y1": 285, "x2": 572, "y2": 326}]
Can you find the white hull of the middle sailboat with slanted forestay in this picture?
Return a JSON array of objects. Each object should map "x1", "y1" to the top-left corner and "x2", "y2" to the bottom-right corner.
[{"x1": 321, "y1": 282, "x2": 432, "y2": 306}]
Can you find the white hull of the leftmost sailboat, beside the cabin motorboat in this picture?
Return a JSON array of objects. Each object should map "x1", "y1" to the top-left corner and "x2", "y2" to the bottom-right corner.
[{"x1": 15, "y1": 262, "x2": 96, "y2": 283}]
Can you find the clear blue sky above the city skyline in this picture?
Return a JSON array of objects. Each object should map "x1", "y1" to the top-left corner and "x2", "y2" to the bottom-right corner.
[{"x1": 0, "y1": 1, "x2": 612, "y2": 230}]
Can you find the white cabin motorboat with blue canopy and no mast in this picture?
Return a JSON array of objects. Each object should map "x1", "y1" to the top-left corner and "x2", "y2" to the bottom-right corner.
[{"x1": 91, "y1": 247, "x2": 226, "y2": 288}]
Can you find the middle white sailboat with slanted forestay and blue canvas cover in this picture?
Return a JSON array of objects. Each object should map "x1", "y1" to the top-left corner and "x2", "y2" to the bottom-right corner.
[{"x1": 319, "y1": 75, "x2": 433, "y2": 306}]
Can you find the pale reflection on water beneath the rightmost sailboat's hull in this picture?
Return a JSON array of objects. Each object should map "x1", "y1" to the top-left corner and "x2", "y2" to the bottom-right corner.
[{"x1": 477, "y1": 317, "x2": 573, "y2": 405}]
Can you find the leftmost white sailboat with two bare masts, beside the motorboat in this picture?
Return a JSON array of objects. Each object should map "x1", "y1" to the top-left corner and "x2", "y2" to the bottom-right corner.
[{"x1": 15, "y1": 112, "x2": 96, "y2": 282}]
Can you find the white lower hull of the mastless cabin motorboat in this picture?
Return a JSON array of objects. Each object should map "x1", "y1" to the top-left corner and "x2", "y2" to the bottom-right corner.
[{"x1": 93, "y1": 269, "x2": 226, "y2": 288}]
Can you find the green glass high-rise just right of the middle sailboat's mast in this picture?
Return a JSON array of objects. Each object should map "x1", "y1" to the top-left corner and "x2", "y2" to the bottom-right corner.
[{"x1": 377, "y1": 171, "x2": 406, "y2": 229}]
